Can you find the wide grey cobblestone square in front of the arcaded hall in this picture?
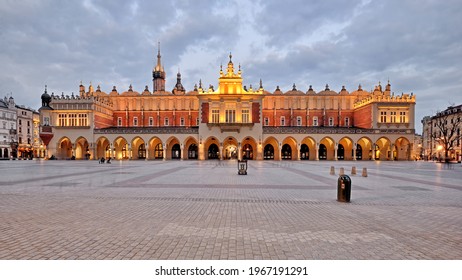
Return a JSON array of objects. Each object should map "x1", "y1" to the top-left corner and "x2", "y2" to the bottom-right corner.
[{"x1": 0, "y1": 161, "x2": 462, "y2": 260}]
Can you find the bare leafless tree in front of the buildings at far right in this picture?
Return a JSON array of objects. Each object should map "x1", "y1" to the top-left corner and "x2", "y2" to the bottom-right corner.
[{"x1": 432, "y1": 106, "x2": 462, "y2": 161}]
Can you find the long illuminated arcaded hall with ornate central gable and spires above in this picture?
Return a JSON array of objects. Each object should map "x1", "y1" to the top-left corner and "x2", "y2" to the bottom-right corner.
[{"x1": 39, "y1": 51, "x2": 415, "y2": 160}]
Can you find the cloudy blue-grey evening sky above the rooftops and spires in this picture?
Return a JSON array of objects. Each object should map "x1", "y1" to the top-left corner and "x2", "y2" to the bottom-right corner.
[{"x1": 0, "y1": 0, "x2": 462, "y2": 133}]
